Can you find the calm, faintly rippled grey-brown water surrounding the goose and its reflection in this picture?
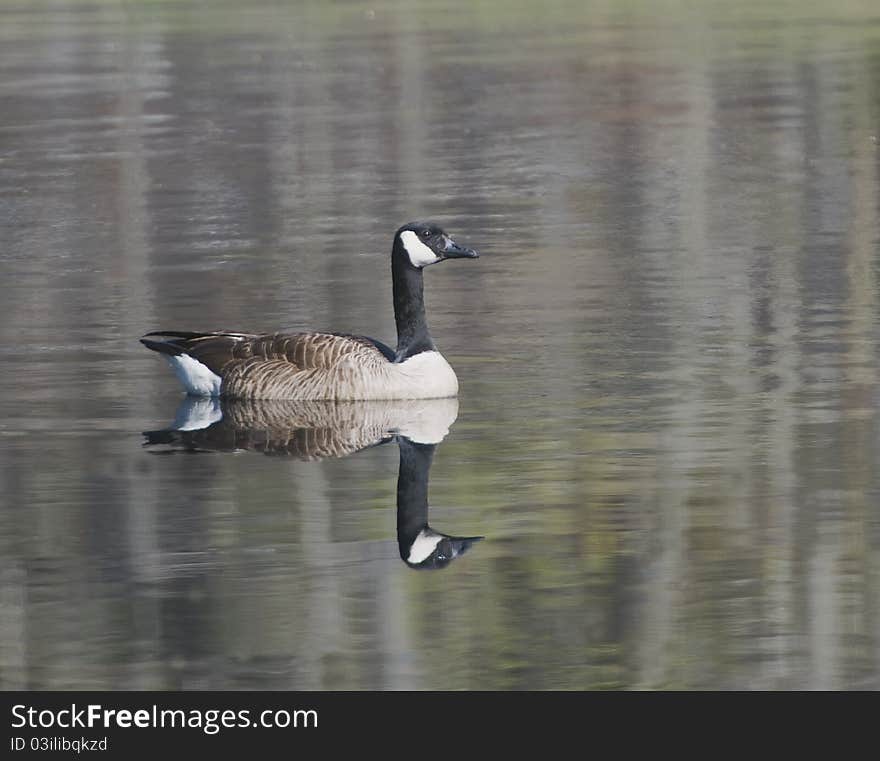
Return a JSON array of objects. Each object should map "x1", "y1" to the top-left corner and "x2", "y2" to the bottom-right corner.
[{"x1": 0, "y1": 0, "x2": 880, "y2": 689}]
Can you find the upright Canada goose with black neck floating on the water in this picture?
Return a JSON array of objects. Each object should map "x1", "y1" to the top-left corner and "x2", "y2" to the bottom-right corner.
[{"x1": 141, "y1": 222, "x2": 478, "y2": 400}]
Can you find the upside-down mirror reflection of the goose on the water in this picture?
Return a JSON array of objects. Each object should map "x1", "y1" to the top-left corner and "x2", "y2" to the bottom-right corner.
[{"x1": 144, "y1": 397, "x2": 483, "y2": 569}]
